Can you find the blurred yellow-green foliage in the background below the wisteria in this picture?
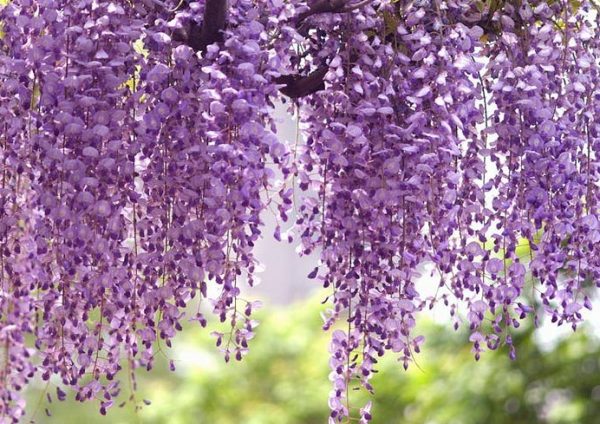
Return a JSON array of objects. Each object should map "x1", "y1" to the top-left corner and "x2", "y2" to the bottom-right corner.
[{"x1": 26, "y1": 298, "x2": 600, "y2": 424}]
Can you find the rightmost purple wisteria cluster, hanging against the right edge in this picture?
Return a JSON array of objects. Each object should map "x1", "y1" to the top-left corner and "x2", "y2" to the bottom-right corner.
[{"x1": 450, "y1": 2, "x2": 599, "y2": 357}]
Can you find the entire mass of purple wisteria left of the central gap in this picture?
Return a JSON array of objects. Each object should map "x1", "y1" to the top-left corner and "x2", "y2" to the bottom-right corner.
[{"x1": 0, "y1": 0, "x2": 293, "y2": 420}]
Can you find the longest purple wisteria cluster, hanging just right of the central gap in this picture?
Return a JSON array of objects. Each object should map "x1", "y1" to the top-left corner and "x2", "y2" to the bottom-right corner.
[{"x1": 298, "y1": 0, "x2": 483, "y2": 421}]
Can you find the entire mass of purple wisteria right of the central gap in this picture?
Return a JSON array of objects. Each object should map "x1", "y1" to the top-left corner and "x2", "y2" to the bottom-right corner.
[{"x1": 298, "y1": 1, "x2": 600, "y2": 422}]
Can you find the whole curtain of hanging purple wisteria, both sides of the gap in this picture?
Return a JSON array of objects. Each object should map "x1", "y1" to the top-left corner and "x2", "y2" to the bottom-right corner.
[{"x1": 0, "y1": 0, "x2": 600, "y2": 423}]
